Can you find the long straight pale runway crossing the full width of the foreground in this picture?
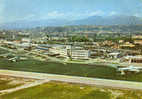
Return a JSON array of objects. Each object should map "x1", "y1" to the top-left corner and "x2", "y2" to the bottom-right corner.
[{"x1": 0, "y1": 70, "x2": 142, "y2": 90}]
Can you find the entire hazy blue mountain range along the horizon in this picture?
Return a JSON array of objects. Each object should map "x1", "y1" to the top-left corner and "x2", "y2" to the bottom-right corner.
[{"x1": 0, "y1": 15, "x2": 142, "y2": 29}]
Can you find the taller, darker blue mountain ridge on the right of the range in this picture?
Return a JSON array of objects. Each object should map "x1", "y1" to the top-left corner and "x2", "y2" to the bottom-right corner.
[{"x1": 71, "y1": 15, "x2": 142, "y2": 25}]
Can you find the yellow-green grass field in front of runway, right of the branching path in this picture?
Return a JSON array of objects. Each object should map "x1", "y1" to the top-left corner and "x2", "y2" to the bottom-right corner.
[{"x1": 0, "y1": 82, "x2": 142, "y2": 99}]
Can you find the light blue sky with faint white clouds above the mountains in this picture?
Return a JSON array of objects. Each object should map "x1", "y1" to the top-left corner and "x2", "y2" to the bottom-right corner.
[{"x1": 0, "y1": 0, "x2": 142, "y2": 23}]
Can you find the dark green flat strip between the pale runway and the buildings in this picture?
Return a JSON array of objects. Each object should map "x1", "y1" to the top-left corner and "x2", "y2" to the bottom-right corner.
[{"x1": 0, "y1": 59, "x2": 142, "y2": 82}]
